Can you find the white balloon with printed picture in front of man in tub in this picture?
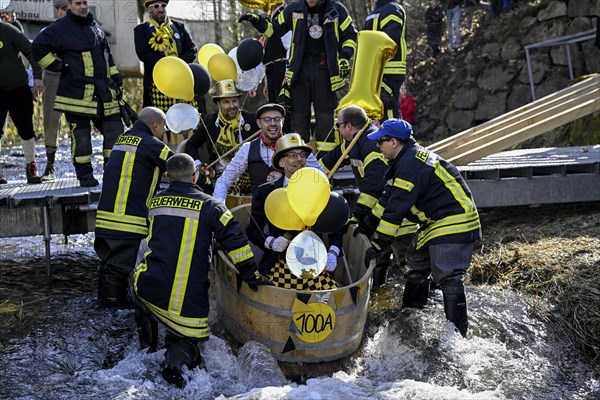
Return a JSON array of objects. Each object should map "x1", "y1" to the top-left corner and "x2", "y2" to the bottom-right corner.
[{"x1": 285, "y1": 231, "x2": 327, "y2": 279}]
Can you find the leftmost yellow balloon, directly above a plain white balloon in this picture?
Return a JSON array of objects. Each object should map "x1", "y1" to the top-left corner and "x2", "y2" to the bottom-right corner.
[{"x1": 152, "y1": 56, "x2": 194, "y2": 100}]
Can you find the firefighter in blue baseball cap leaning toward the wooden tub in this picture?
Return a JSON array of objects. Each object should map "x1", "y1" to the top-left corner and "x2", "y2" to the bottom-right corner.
[{"x1": 365, "y1": 119, "x2": 481, "y2": 336}]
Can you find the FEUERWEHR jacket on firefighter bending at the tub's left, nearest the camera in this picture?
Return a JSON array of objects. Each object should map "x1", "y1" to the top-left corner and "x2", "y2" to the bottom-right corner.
[{"x1": 134, "y1": 182, "x2": 256, "y2": 340}]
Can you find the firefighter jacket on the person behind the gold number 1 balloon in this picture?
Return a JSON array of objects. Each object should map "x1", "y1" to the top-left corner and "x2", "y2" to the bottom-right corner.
[{"x1": 364, "y1": 0, "x2": 406, "y2": 90}]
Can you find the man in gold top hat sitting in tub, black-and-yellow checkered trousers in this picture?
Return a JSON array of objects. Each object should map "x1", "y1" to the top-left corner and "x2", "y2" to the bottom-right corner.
[{"x1": 246, "y1": 133, "x2": 343, "y2": 290}]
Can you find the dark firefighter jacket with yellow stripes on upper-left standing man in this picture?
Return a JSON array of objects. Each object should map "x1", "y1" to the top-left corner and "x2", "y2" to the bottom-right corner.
[{"x1": 32, "y1": 10, "x2": 123, "y2": 117}]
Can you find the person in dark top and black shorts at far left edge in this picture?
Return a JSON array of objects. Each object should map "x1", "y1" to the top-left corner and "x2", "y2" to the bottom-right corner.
[{"x1": 0, "y1": 14, "x2": 43, "y2": 183}]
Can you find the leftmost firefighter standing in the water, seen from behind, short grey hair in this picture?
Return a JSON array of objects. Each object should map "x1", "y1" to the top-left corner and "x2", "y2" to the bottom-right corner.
[{"x1": 94, "y1": 107, "x2": 173, "y2": 307}]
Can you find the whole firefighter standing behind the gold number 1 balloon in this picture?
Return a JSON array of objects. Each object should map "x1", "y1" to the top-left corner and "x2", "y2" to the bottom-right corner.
[{"x1": 364, "y1": 0, "x2": 406, "y2": 120}]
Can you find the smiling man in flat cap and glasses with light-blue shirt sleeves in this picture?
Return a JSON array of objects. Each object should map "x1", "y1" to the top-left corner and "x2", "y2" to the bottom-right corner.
[{"x1": 213, "y1": 103, "x2": 323, "y2": 201}]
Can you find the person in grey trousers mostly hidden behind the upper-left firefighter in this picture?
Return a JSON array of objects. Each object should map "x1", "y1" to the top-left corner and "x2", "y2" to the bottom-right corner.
[{"x1": 42, "y1": 0, "x2": 69, "y2": 181}]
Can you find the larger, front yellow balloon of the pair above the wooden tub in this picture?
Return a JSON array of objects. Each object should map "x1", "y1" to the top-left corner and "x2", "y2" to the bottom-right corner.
[{"x1": 287, "y1": 167, "x2": 331, "y2": 226}]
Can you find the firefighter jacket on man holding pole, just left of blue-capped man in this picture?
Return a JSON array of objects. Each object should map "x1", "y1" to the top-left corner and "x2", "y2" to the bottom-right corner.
[{"x1": 319, "y1": 123, "x2": 387, "y2": 221}]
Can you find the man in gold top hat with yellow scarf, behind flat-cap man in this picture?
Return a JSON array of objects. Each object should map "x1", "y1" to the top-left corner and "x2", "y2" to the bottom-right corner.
[{"x1": 182, "y1": 79, "x2": 258, "y2": 193}]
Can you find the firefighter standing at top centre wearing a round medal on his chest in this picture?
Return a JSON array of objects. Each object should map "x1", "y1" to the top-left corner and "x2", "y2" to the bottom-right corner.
[{"x1": 238, "y1": 0, "x2": 357, "y2": 156}]
